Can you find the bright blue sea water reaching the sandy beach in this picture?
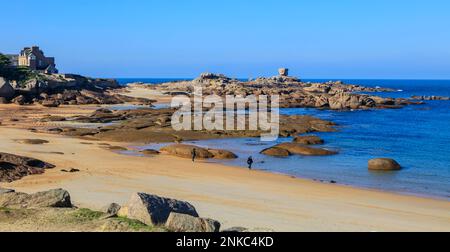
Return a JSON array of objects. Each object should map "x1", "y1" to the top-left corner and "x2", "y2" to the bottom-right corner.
[{"x1": 117, "y1": 79, "x2": 450, "y2": 200}]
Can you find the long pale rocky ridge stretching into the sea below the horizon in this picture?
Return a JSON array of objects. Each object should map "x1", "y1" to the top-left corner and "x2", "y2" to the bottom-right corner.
[{"x1": 130, "y1": 73, "x2": 423, "y2": 110}]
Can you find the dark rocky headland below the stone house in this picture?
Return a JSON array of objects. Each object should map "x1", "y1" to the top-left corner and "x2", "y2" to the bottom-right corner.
[{"x1": 0, "y1": 73, "x2": 154, "y2": 107}]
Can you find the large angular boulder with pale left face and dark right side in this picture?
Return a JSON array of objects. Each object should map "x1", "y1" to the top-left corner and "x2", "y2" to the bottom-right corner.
[{"x1": 119, "y1": 193, "x2": 198, "y2": 226}]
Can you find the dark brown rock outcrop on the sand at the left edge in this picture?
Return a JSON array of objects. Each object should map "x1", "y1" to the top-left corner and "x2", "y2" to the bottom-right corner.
[{"x1": 0, "y1": 152, "x2": 55, "y2": 182}]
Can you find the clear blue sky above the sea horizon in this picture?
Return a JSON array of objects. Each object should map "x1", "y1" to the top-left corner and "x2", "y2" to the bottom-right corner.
[{"x1": 0, "y1": 0, "x2": 450, "y2": 79}]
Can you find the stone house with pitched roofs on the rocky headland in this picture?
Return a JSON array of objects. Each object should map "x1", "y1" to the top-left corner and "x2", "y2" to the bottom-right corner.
[{"x1": 7, "y1": 46, "x2": 58, "y2": 74}]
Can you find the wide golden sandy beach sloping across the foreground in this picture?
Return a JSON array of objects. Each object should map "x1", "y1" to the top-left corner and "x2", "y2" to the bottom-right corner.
[{"x1": 0, "y1": 122, "x2": 450, "y2": 231}]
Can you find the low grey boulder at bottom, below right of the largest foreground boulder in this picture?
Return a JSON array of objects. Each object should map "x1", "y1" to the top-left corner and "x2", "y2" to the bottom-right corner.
[{"x1": 166, "y1": 212, "x2": 220, "y2": 232}]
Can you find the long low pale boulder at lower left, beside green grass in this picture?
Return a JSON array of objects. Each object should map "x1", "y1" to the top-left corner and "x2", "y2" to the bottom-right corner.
[{"x1": 0, "y1": 189, "x2": 72, "y2": 208}]
